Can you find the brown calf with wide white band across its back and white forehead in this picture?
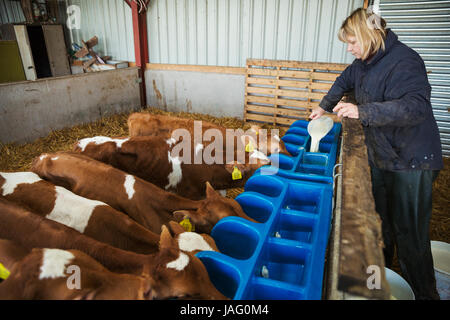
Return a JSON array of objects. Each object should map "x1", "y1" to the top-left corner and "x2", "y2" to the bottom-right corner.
[{"x1": 0, "y1": 172, "x2": 217, "y2": 254}]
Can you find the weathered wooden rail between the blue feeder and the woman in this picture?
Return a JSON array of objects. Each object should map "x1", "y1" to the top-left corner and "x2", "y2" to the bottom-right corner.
[{"x1": 338, "y1": 118, "x2": 390, "y2": 299}]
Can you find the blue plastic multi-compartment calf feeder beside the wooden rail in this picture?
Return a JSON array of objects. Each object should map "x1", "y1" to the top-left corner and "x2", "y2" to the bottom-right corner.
[{"x1": 196, "y1": 120, "x2": 341, "y2": 300}]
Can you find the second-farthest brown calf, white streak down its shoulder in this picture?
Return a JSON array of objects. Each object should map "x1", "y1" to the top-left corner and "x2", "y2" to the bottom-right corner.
[{"x1": 73, "y1": 136, "x2": 270, "y2": 200}]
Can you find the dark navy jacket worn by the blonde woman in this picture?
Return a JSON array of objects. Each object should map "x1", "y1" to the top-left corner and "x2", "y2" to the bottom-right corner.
[{"x1": 320, "y1": 29, "x2": 443, "y2": 171}]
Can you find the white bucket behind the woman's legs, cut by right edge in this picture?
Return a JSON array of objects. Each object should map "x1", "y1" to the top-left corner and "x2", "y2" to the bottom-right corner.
[{"x1": 431, "y1": 241, "x2": 450, "y2": 300}]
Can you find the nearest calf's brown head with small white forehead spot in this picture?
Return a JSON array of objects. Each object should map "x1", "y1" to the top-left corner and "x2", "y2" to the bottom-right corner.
[{"x1": 145, "y1": 225, "x2": 227, "y2": 300}]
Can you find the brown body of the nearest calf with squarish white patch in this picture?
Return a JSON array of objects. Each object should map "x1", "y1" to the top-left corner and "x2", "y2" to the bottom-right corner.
[{"x1": 0, "y1": 240, "x2": 151, "y2": 300}]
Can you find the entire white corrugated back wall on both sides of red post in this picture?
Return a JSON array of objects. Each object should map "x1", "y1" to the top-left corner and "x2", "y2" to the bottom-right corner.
[{"x1": 0, "y1": 0, "x2": 363, "y2": 63}]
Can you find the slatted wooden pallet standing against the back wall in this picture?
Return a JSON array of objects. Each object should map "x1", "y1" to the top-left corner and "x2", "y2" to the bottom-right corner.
[{"x1": 244, "y1": 59, "x2": 347, "y2": 126}]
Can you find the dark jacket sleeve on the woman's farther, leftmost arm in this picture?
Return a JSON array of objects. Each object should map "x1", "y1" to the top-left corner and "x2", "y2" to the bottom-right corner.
[{"x1": 319, "y1": 64, "x2": 355, "y2": 112}]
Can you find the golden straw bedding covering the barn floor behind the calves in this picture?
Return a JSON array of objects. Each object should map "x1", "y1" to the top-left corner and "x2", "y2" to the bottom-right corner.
[{"x1": 0, "y1": 108, "x2": 450, "y2": 243}]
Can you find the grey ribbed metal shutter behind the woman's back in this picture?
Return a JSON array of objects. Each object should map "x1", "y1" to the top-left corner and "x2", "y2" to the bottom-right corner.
[{"x1": 380, "y1": 0, "x2": 450, "y2": 156}]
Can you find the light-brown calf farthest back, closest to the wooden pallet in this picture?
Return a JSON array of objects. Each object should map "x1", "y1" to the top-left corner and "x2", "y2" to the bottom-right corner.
[{"x1": 128, "y1": 112, "x2": 289, "y2": 155}]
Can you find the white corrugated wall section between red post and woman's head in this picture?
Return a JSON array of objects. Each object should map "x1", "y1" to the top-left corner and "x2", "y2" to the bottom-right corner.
[{"x1": 147, "y1": 0, "x2": 363, "y2": 67}]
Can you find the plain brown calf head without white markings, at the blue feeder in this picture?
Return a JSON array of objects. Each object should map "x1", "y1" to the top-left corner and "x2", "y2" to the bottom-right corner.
[{"x1": 173, "y1": 182, "x2": 256, "y2": 234}]
